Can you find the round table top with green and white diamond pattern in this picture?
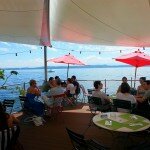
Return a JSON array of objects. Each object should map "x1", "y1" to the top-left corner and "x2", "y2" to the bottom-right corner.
[{"x1": 93, "y1": 112, "x2": 150, "y2": 132}]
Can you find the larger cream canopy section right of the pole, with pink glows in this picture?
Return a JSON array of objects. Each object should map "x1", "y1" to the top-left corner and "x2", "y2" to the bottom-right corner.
[{"x1": 50, "y1": 0, "x2": 150, "y2": 47}]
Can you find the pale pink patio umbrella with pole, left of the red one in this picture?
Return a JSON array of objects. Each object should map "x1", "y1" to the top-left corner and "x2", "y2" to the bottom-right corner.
[{"x1": 48, "y1": 53, "x2": 85, "y2": 78}]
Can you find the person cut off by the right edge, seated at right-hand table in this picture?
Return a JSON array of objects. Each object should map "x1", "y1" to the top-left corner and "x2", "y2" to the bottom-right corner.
[{"x1": 135, "y1": 80, "x2": 150, "y2": 119}]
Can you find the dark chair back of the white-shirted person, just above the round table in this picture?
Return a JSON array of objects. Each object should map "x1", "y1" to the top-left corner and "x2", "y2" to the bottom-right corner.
[{"x1": 113, "y1": 99, "x2": 135, "y2": 113}]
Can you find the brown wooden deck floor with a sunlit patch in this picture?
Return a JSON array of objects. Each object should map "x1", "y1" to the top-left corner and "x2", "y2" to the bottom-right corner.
[{"x1": 17, "y1": 105, "x2": 148, "y2": 150}]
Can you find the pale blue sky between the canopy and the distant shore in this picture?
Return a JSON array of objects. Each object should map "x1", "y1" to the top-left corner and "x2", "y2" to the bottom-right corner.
[{"x1": 0, "y1": 41, "x2": 150, "y2": 68}]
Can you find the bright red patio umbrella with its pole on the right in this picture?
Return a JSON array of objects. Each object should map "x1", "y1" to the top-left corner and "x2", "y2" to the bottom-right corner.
[{"x1": 115, "y1": 50, "x2": 150, "y2": 87}]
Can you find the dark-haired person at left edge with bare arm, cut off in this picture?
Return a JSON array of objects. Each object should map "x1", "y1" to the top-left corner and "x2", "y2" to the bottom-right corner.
[{"x1": 0, "y1": 103, "x2": 19, "y2": 130}]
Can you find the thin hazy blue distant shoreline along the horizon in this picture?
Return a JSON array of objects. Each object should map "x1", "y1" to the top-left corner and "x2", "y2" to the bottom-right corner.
[{"x1": 1, "y1": 65, "x2": 149, "y2": 70}]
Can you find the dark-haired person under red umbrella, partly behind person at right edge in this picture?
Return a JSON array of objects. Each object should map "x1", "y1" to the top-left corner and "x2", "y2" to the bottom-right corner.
[{"x1": 137, "y1": 77, "x2": 146, "y2": 97}]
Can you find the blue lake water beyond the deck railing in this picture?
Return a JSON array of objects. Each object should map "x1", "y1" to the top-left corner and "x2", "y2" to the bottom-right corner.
[{"x1": 0, "y1": 67, "x2": 150, "y2": 110}]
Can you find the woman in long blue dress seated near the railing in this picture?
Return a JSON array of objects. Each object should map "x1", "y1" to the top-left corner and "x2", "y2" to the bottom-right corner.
[{"x1": 24, "y1": 80, "x2": 44, "y2": 116}]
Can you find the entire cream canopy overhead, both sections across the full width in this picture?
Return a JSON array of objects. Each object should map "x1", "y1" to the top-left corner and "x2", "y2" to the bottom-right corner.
[{"x1": 0, "y1": 0, "x2": 150, "y2": 47}]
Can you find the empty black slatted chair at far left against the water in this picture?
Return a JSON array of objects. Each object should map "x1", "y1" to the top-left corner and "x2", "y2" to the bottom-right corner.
[{"x1": 3, "y1": 99, "x2": 15, "y2": 114}]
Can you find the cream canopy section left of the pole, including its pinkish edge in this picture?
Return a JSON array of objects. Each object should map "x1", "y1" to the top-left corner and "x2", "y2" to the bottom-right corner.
[{"x1": 0, "y1": 0, "x2": 50, "y2": 46}]
